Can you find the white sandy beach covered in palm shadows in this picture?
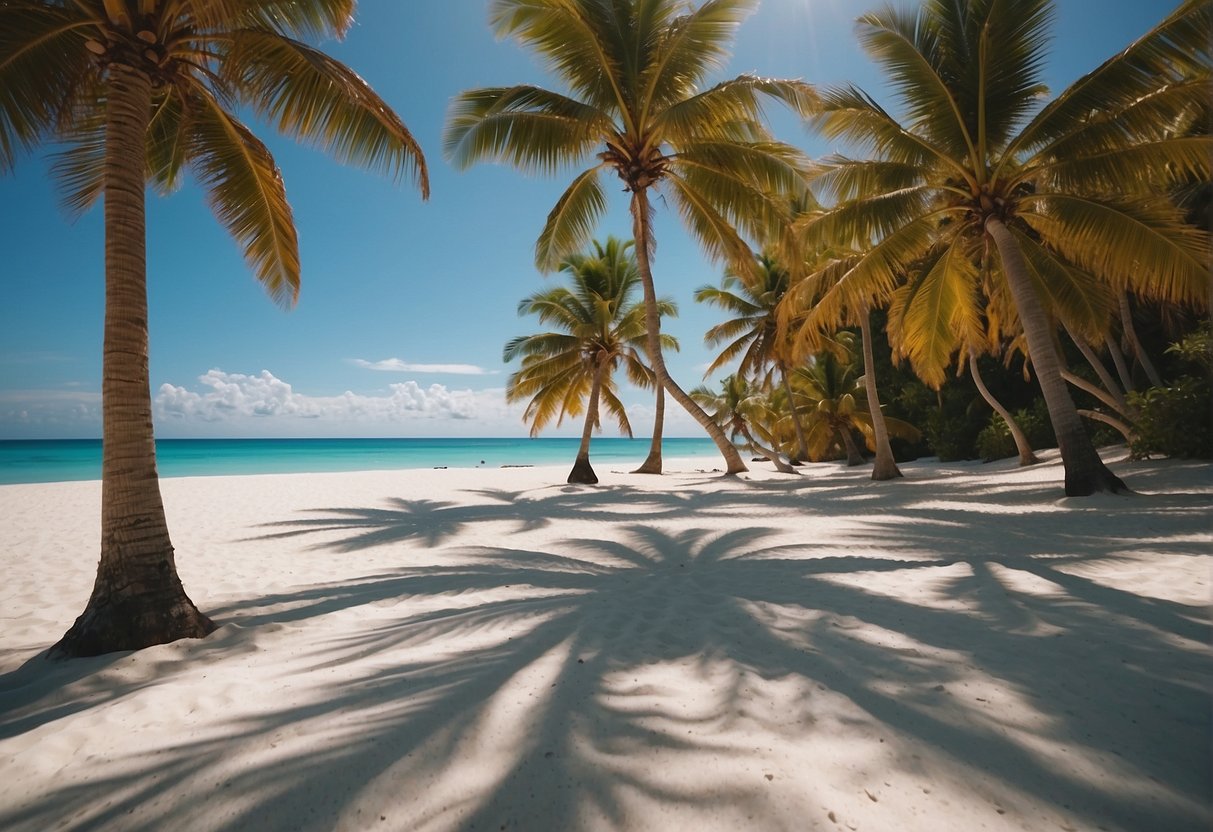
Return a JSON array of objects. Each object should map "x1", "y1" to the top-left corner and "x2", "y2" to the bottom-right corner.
[{"x1": 0, "y1": 451, "x2": 1213, "y2": 832}]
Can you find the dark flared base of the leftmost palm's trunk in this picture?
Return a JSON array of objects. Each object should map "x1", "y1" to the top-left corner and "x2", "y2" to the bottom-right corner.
[{"x1": 47, "y1": 582, "x2": 215, "y2": 659}]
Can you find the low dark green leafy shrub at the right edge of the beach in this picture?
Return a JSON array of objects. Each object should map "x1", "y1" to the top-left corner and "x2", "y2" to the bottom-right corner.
[{"x1": 1129, "y1": 376, "x2": 1213, "y2": 460}]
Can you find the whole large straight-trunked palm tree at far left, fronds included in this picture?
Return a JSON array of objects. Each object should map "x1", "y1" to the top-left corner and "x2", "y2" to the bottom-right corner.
[{"x1": 0, "y1": 0, "x2": 428, "y2": 656}]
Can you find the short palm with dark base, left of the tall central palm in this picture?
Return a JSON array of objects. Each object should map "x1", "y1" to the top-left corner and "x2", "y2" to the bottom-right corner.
[{"x1": 503, "y1": 237, "x2": 677, "y2": 484}]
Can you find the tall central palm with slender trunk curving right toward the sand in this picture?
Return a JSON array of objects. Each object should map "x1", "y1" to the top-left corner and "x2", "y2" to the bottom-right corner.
[{"x1": 444, "y1": 0, "x2": 815, "y2": 474}]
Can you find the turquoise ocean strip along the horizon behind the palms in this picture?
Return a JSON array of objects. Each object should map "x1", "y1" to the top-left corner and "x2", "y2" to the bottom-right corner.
[{"x1": 0, "y1": 437, "x2": 718, "y2": 485}]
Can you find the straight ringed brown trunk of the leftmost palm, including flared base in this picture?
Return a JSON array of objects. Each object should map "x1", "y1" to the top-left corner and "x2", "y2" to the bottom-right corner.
[{"x1": 50, "y1": 63, "x2": 215, "y2": 657}]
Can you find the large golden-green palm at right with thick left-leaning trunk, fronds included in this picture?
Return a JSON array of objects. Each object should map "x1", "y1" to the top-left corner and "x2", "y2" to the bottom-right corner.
[{"x1": 800, "y1": 0, "x2": 1213, "y2": 495}]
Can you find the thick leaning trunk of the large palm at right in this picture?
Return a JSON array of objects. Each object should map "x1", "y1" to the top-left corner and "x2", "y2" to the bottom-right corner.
[{"x1": 985, "y1": 217, "x2": 1128, "y2": 497}]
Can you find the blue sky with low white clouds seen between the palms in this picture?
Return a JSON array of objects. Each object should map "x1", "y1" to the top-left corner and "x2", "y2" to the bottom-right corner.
[{"x1": 0, "y1": 0, "x2": 1172, "y2": 439}]
